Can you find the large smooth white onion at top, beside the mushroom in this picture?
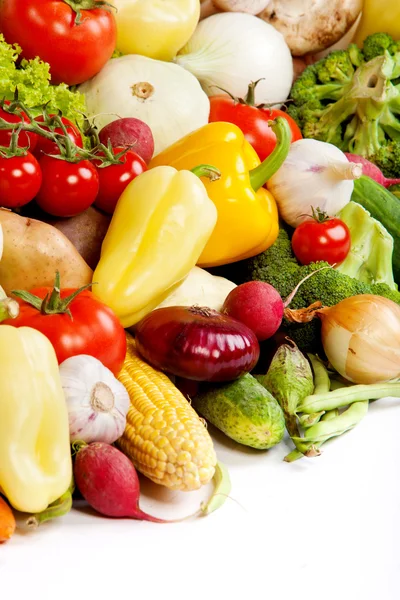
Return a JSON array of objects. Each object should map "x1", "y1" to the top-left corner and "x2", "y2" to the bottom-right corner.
[{"x1": 175, "y1": 13, "x2": 293, "y2": 104}]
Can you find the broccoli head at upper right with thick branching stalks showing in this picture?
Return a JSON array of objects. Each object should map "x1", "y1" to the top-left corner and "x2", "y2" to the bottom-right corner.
[{"x1": 289, "y1": 33, "x2": 400, "y2": 177}]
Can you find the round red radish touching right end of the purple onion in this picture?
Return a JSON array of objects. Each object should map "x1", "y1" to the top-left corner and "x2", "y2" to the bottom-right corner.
[{"x1": 222, "y1": 281, "x2": 284, "y2": 342}]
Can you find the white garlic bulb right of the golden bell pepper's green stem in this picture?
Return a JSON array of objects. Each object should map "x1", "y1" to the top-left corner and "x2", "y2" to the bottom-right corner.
[{"x1": 267, "y1": 139, "x2": 362, "y2": 227}]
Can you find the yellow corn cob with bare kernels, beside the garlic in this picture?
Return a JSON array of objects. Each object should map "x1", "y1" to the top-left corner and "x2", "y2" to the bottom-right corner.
[{"x1": 116, "y1": 334, "x2": 217, "y2": 491}]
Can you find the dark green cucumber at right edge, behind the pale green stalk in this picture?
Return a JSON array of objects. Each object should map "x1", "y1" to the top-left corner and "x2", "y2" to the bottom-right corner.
[{"x1": 351, "y1": 175, "x2": 400, "y2": 285}]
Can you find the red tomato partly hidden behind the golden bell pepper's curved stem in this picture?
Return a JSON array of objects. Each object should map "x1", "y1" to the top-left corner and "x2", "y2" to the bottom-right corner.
[{"x1": 209, "y1": 96, "x2": 303, "y2": 161}]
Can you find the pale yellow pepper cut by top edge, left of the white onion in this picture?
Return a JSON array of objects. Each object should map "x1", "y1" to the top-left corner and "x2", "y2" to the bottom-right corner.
[{"x1": 112, "y1": 0, "x2": 200, "y2": 61}]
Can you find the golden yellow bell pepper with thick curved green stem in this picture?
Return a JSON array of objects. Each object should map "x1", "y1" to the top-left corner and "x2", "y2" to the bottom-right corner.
[{"x1": 149, "y1": 117, "x2": 291, "y2": 267}]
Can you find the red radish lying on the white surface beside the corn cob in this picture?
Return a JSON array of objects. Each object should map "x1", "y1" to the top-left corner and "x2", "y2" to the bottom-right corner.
[{"x1": 74, "y1": 442, "x2": 168, "y2": 523}]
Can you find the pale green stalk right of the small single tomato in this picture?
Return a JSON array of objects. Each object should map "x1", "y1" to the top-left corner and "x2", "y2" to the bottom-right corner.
[{"x1": 336, "y1": 202, "x2": 397, "y2": 290}]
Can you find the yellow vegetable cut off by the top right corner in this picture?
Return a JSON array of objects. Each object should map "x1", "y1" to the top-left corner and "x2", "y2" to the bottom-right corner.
[{"x1": 354, "y1": 0, "x2": 400, "y2": 46}]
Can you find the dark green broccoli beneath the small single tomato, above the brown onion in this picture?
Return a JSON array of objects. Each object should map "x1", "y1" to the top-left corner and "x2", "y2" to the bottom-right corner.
[{"x1": 238, "y1": 228, "x2": 400, "y2": 352}]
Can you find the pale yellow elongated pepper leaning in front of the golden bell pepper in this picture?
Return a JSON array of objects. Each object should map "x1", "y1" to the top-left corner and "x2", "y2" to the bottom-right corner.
[{"x1": 93, "y1": 167, "x2": 217, "y2": 327}]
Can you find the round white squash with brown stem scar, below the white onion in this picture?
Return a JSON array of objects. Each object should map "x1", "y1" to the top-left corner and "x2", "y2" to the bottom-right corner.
[{"x1": 79, "y1": 54, "x2": 210, "y2": 155}]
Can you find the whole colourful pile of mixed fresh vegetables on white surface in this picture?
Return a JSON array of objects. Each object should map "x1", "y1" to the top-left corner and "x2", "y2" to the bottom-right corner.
[{"x1": 0, "y1": 0, "x2": 400, "y2": 543}]
